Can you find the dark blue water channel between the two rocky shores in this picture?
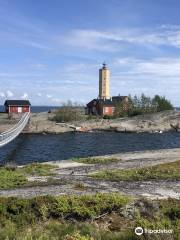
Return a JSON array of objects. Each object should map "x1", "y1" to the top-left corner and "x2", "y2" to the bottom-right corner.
[{"x1": 0, "y1": 132, "x2": 180, "y2": 164}]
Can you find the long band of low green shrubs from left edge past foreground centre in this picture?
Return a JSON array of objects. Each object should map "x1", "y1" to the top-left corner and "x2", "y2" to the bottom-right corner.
[{"x1": 0, "y1": 194, "x2": 129, "y2": 225}]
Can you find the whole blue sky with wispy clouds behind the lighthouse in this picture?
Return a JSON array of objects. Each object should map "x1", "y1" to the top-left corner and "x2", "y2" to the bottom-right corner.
[{"x1": 0, "y1": 0, "x2": 180, "y2": 106}]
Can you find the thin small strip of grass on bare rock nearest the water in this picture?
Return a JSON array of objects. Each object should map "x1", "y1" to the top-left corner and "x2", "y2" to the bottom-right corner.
[{"x1": 73, "y1": 157, "x2": 120, "y2": 164}]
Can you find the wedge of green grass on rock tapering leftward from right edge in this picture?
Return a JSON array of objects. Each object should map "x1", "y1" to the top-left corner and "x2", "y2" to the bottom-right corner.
[{"x1": 91, "y1": 160, "x2": 180, "y2": 181}]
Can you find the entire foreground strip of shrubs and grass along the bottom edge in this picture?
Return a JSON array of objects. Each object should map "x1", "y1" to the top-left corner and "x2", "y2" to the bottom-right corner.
[{"x1": 0, "y1": 194, "x2": 180, "y2": 240}]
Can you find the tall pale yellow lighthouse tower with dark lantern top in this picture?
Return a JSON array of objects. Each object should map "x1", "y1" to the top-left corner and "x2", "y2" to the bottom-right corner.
[{"x1": 99, "y1": 63, "x2": 110, "y2": 100}]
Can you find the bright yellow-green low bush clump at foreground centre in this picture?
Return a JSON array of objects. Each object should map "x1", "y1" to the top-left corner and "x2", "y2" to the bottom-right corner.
[{"x1": 55, "y1": 194, "x2": 128, "y2": 219}]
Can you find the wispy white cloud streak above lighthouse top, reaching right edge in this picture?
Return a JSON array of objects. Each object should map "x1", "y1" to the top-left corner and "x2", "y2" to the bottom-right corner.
[{"x1": 59, "y1": 25, "x2": 180, "y2": 52}]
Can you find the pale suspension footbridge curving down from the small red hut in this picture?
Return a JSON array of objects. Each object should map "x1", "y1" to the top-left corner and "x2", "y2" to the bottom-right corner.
[{"x1": 0, "y1": 112, "x2": 30, "y2": 147}]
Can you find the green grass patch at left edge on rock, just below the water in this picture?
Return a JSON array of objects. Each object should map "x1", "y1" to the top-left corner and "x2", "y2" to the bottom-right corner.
[{"x1": 0, "y1": 163, "x2": 56, "y2": 189}]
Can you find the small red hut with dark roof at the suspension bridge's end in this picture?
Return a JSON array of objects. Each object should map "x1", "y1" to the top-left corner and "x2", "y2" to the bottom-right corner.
[{"x1": 4, "y1": 100, "x2": 31, "y2": 114}]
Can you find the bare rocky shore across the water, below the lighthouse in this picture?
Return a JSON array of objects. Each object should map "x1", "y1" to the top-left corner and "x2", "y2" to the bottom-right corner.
[{"x1": 0, "y1": 111, "x2": 180, "y2": 134}]
